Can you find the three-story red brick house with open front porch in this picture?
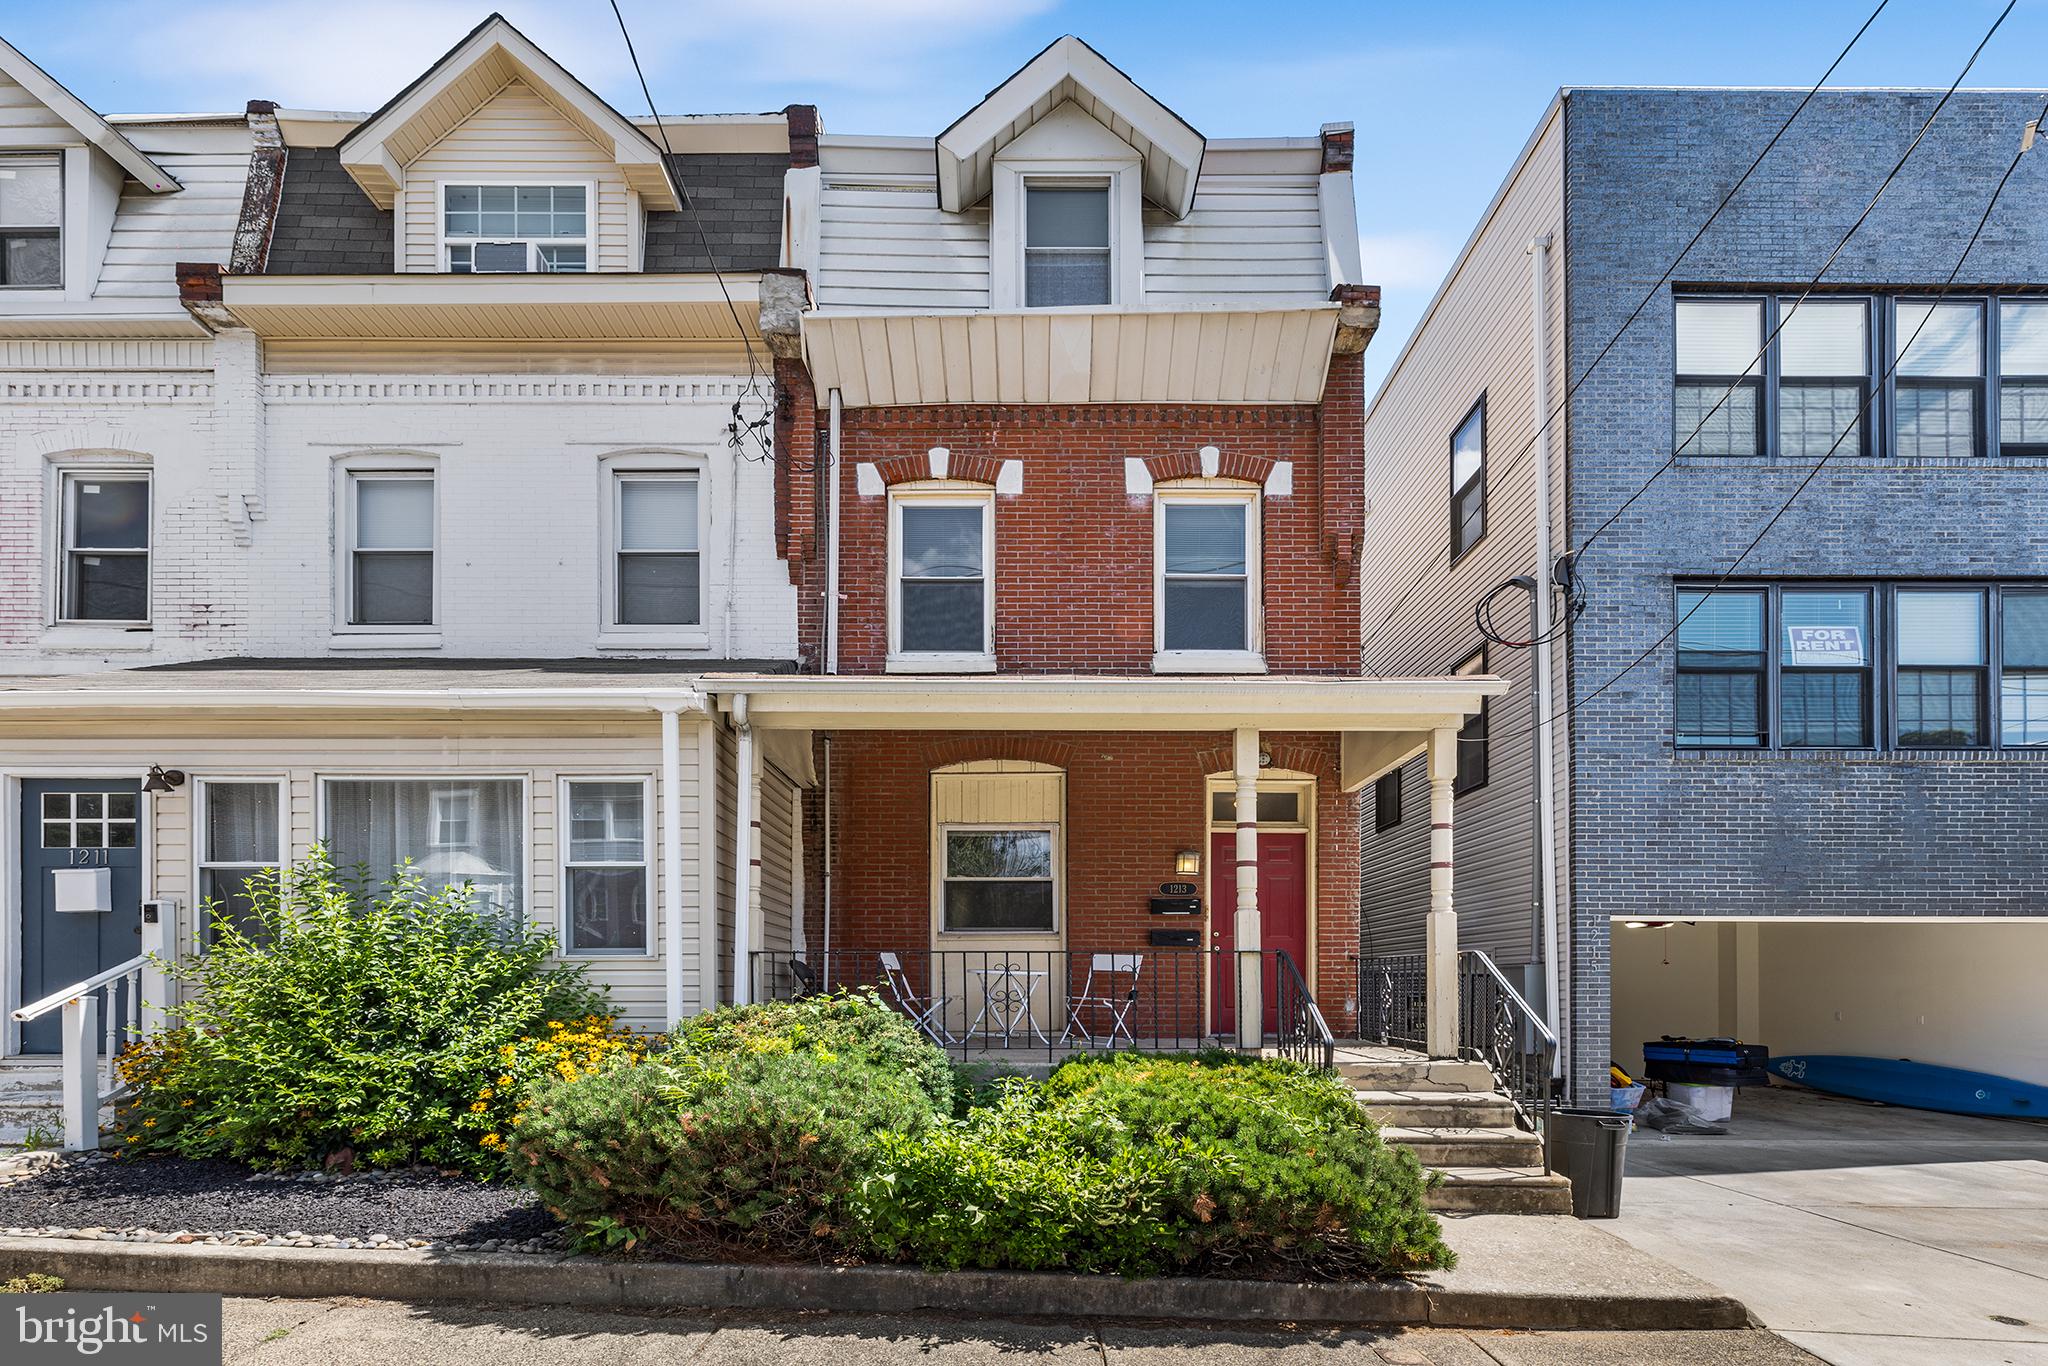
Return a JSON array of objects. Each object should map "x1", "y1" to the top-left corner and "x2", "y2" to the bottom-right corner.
[{"x1": 720, "y1": 37, "x2": 1499, "y2": 1047}]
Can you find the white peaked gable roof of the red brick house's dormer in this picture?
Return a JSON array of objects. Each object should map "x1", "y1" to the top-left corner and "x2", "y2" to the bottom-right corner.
[{"x1": 934, "y1": 33, "x2": 1208, "y2": 219}]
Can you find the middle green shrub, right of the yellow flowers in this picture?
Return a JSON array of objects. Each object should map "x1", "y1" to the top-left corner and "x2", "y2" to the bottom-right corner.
[{"x1": 510, "y1": 993, "x2": 952, "y2": 1255}]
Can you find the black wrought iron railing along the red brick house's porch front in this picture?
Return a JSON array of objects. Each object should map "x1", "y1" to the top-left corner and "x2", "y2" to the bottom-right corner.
[{"x1": 750, "y1": 948, "x2": 1335, "y2": 1067}]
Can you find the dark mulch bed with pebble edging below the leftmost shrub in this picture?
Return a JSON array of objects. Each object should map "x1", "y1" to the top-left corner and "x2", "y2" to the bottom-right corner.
[{"x1": 0, "y1": 1155, "x2": 563, "y2": 1251}]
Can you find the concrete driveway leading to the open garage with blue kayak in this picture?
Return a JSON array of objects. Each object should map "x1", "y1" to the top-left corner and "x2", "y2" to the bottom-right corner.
[{"x1": 1606, "y1": 1087, "x2": 2048, "y2": 1366}]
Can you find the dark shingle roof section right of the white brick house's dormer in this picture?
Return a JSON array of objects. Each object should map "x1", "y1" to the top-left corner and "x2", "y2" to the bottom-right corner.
[{"x1": 647, "y1": 152, "x2": 788, "y2": 272}]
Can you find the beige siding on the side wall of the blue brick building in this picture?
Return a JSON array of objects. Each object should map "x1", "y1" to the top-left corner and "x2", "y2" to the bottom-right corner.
[{"x1": 1360, "y1": 109, "x2": 1569, "y2": 983}]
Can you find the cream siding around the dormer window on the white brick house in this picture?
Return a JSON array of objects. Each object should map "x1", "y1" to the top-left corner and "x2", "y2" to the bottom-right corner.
[{"x1": 401, "y1": 82, "x2": 635, "y2": 270}]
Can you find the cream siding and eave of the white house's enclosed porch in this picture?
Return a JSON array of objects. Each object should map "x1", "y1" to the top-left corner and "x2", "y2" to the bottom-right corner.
[{"x1": 6, "y1": 723, "x2": 698, "y2": 1030}]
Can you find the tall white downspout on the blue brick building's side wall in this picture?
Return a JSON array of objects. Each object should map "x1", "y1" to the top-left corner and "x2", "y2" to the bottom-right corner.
[{"x1": 1528, "y1": 233, "x2": 1565, "y2": 1077}]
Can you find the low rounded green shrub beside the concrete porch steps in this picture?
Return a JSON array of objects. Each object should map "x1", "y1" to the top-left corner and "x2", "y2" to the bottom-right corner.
[{"x1": 852, "y1": 1055, "x2": 1452, "y2": 1276}]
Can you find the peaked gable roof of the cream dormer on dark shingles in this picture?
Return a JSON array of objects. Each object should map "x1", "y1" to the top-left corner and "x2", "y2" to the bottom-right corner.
[{"x1": 338, "y1": 14, "x2": 680, "y2": 209}]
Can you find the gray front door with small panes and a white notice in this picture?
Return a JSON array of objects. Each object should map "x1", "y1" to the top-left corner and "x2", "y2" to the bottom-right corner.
[{"x1": 18, "y1": 778, "x2": 141, "y2": 1053}]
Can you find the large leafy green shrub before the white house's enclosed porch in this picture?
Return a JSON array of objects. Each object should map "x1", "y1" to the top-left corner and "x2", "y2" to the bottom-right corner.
[{"x1": 115, "y1": 848, "x2": 616, "y2": 1176}]
